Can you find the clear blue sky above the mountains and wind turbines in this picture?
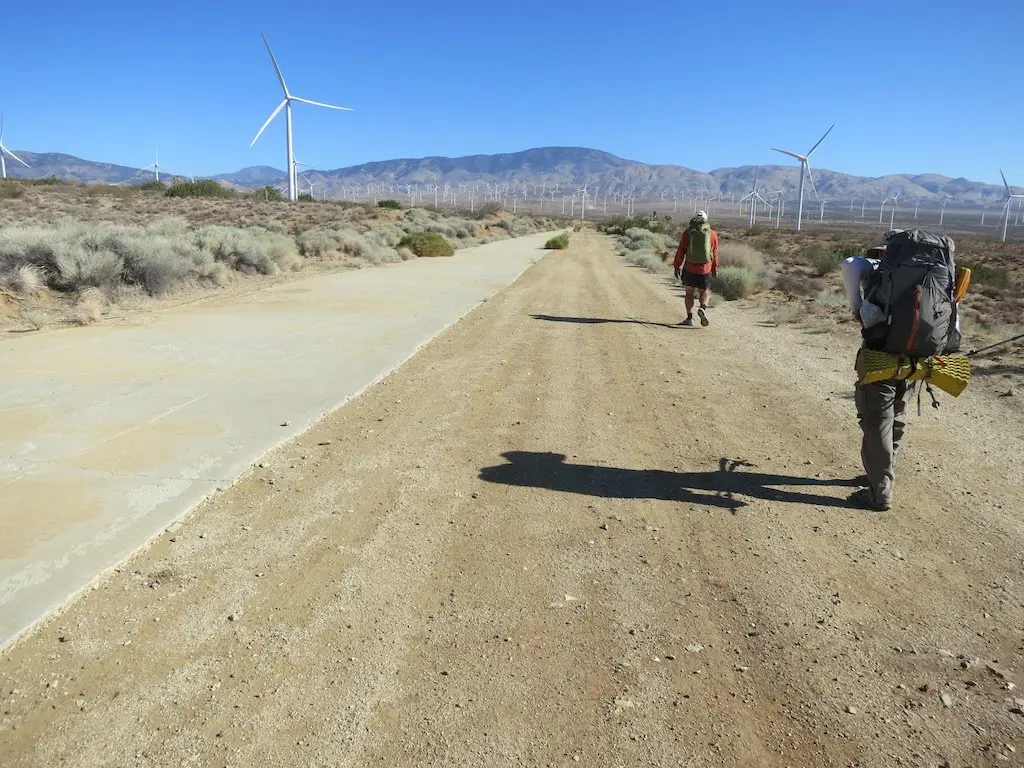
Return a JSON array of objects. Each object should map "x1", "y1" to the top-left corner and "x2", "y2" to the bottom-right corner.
[{"x1": 0, "y1": 0, "x2": 1024, "y2": 186}]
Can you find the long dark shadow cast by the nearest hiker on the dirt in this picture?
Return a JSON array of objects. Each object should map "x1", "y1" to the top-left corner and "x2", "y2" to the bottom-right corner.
[{"x1": 480, "y1": 451, "x2": 857, "y2": 513}]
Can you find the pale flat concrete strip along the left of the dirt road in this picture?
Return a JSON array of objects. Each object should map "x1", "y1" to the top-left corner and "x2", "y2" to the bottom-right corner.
[{"x1": 0, "y1": 236, "x2": 547, "y2": 646}]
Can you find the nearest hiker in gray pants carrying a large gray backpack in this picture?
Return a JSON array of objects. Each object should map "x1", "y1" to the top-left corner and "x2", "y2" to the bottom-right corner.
[{"x1": 842, "y1": 229, "x2": 969, "y2": 511}]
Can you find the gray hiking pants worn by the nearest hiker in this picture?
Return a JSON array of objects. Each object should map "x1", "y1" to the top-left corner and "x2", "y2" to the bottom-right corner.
[{"x1": 856, "y1": 381, "x2": 914, "y2": 506}]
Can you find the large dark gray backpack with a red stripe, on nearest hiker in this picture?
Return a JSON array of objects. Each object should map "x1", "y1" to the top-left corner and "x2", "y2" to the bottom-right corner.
[{"x1": 864, "y1": 229, "x2": 961, "y2": 357}]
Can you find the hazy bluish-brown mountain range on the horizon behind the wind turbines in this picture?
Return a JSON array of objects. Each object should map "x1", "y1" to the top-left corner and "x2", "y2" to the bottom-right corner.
[{"x1": 7, "y1": 146, "x2": 1006, "y2": 207}]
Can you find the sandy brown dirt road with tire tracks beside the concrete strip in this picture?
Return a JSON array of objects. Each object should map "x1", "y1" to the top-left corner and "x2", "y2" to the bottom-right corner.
[{"x1": 0, "y1": 231, "x2": 1024, "y2": 767}]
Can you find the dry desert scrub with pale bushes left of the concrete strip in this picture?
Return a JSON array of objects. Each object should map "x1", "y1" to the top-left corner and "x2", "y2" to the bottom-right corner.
[{"x1": 0, "y1": 186, "x2": 555, "y2": 328}]
